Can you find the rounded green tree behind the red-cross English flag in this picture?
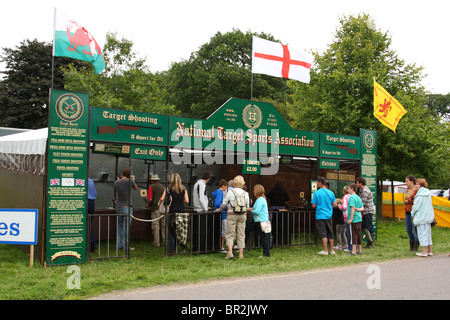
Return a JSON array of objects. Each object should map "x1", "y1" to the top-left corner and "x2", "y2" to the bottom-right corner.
[{"x1": 168, "y1": 29, "x2": 290, "y2": 118}]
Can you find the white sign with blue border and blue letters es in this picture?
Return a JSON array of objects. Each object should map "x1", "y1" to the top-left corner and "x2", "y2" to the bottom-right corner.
[{"x1": 0, "y1": 209, "x2": 38, "y2": 245}]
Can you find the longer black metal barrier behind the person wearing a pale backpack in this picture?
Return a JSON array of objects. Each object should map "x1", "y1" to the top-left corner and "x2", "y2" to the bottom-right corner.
[{"x1": 165, "y1": 210, "x2": 317, "y2": 256}]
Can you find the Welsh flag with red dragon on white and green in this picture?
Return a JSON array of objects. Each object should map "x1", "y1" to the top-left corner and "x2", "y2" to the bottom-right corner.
[{"x1": 53, "y1": 8, "x2": 105, "y2": 74}]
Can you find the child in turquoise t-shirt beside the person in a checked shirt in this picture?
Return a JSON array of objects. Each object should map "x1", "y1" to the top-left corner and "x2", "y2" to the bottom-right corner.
[{"x1": 347, "y1": 183, "x2": 364, "y2": 255}]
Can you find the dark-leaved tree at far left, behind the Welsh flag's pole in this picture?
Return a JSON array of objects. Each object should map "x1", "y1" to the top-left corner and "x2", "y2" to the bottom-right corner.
[{"x1": 0, "y1": 39, "x2": 84, "y2": 129}]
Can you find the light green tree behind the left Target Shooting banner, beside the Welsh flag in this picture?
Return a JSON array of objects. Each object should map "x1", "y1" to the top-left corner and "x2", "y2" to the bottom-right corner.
[{"x1": 64, "y1": 33, "x2": 177, "y2": 114}]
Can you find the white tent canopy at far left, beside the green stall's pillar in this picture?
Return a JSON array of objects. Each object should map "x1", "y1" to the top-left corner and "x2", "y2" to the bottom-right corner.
[{"x1": 0, "y1": 128, "x2": 48, "y2": 175}]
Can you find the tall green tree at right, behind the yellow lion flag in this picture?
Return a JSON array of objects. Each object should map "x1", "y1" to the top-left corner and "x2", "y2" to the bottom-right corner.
[{"x1": 289, "y1": 14, "x2": 450, "y2": 186}]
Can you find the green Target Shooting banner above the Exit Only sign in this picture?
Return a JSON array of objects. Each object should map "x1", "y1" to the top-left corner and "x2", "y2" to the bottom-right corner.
[{"x1": 89, "y1": 108, "x2": 169, "y2": 146}]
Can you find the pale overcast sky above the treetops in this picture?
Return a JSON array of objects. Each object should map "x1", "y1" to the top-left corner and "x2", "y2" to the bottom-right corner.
[{"x1": 0, "y1": 0, "x2": 450, "y2": 94}]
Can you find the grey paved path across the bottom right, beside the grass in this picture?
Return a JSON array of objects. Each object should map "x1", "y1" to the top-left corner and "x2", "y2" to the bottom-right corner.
[{"x1": 92, "y1": 255, "x2": 450, "y2": 306}]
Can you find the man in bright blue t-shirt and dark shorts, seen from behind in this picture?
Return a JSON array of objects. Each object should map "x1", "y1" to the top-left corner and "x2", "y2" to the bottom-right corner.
[{"x1": 311, "y1": 177, "x2": 337, "y2": 255}]
